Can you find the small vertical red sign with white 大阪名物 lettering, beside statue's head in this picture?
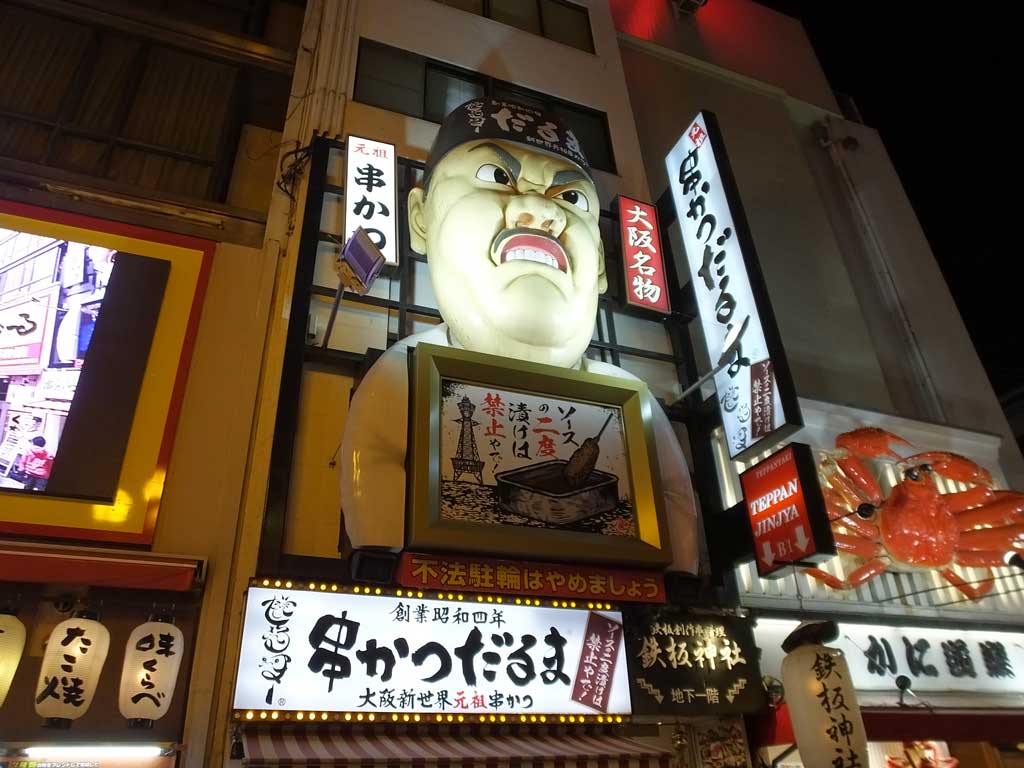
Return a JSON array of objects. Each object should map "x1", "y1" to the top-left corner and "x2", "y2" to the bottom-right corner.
[{"x1": 618, "y1": 197, "x2": 672, "y2": 314}]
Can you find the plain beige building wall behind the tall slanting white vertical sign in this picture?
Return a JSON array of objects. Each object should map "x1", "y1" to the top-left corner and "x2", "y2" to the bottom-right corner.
[{"x1": 622, "y1": 39, "x2": 893, "y2": 411}]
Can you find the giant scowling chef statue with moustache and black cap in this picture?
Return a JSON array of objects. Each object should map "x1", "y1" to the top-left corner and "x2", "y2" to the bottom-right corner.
[{"x1": 341, "y1": 99, "x2": 697, "y2": 572}]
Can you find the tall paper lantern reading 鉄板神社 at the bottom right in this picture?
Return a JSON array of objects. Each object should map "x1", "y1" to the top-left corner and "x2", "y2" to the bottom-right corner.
[{"x1": 782, "y1": 644, "x2": 867, "y2": 768}]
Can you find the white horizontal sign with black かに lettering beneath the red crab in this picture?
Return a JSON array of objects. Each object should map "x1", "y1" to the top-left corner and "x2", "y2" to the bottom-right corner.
[{"x1": 754, "y1": 618, "x2": 1024, "y2": 693}]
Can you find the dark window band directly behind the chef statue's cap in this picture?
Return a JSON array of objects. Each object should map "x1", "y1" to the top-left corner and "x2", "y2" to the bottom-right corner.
[{"x1": 354, "y1": 39, "x2": 615, "y2": 173}]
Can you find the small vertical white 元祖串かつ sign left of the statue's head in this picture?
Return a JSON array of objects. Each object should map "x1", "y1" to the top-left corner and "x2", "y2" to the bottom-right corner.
[{"x1": 345, "y1": 135, "x2": 398, "y2": 264}]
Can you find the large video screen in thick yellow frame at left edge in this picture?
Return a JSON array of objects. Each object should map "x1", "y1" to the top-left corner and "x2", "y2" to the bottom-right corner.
[{"x1": 0, "y1": 201, "x2": 213, "y2": 544}]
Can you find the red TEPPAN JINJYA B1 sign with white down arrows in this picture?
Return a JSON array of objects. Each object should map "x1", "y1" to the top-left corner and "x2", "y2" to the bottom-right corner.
[{"x1": 739, "y1": 442, "x2": 836, "y2": 577}]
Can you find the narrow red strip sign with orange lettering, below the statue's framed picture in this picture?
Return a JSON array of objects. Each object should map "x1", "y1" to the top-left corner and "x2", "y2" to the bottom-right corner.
[{"x1": 395, "y1": 552, "x2": 665, "y2": 608}]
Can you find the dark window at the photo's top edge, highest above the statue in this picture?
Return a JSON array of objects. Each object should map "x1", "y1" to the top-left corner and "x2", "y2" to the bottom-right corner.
[{"x1": 439, "y1": 0, "x2": 594, "y2": 53}]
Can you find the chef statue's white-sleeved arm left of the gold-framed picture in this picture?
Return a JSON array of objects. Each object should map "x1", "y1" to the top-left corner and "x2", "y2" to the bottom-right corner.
[{"x1": 341, "y1": 343, "x2": 409, "y2": 550}]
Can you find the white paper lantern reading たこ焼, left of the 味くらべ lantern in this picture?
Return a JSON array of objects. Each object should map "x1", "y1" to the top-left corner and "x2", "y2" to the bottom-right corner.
[{"x1": 36, "y1": 617, "x2": 111, "y2": 720}]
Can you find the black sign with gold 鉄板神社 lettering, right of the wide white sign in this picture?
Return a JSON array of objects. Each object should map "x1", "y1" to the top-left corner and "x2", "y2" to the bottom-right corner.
[{"x1": 626, "y1": 610, "x2": 764, "y2": 715}]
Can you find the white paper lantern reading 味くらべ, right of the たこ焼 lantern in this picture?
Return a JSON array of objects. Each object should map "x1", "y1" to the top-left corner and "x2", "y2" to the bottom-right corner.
[{"x1": 118, "y1": 622, "x2": 185, "y2": 720}]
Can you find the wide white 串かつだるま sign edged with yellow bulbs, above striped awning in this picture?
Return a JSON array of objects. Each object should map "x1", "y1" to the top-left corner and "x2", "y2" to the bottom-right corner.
[{"x1": 234, "y1": 587, "x2": 630, "y2": 715}]
